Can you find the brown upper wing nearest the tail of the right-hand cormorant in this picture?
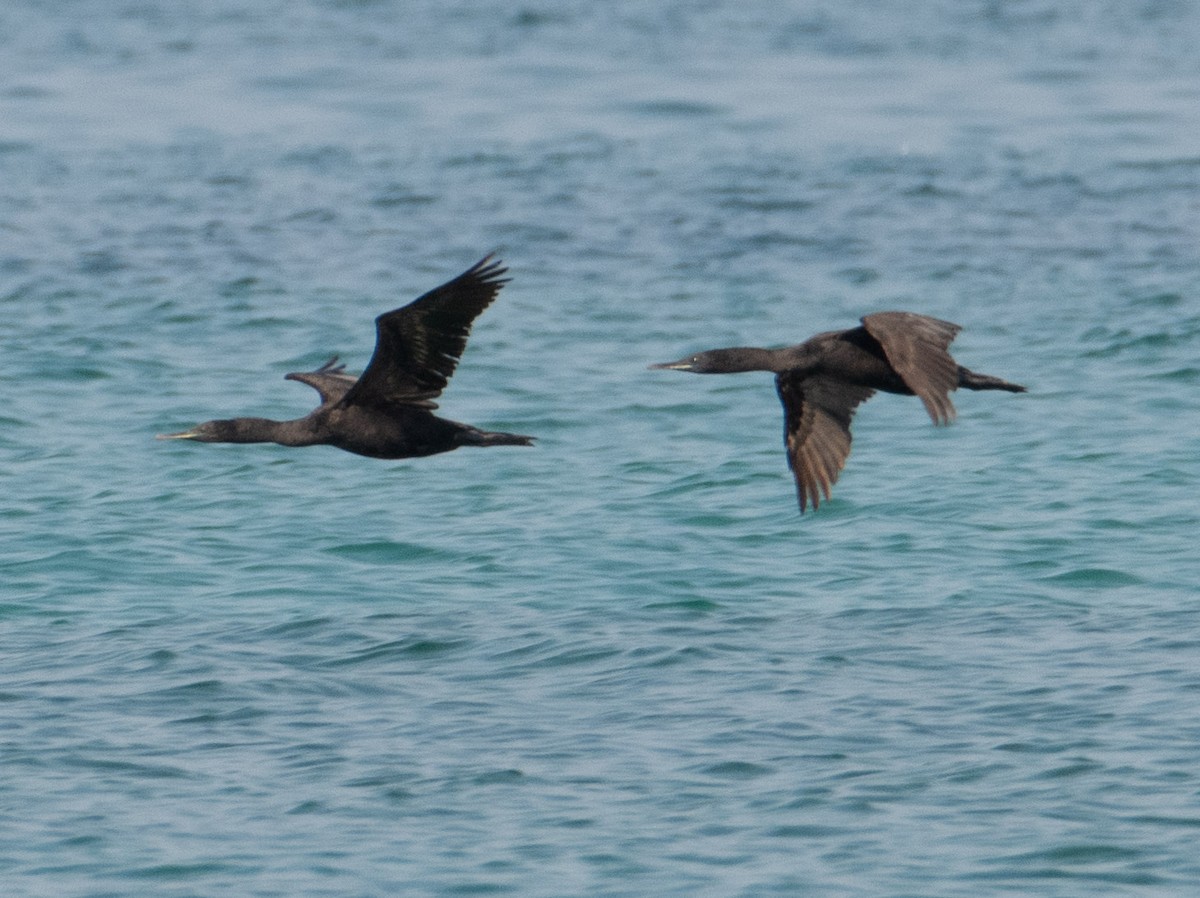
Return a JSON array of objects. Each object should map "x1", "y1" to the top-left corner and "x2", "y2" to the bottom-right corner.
[{"x1": 863, "y1": 312, "x2": 962, "y2": 424}]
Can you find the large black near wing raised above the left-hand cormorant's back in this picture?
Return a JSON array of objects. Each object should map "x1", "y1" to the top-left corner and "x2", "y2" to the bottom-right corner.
[{"x1": 342, "y1": 250, "x2": 508, "y2": 408}]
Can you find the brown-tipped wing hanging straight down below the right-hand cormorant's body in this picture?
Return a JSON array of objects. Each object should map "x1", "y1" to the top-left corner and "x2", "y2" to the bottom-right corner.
[{"x1": 775, "y1": 371, "x2": 875, "y2": 513}]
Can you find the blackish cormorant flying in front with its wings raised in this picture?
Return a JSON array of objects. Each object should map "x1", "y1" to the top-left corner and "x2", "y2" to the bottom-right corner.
[{"x1": 158, "y1": 256, "x2": 533, "y2": 459}]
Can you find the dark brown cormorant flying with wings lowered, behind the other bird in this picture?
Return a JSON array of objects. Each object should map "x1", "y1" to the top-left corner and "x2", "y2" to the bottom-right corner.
[{"x1": 650, "y1": 312, "x2": 1025, "y2": 513}]
